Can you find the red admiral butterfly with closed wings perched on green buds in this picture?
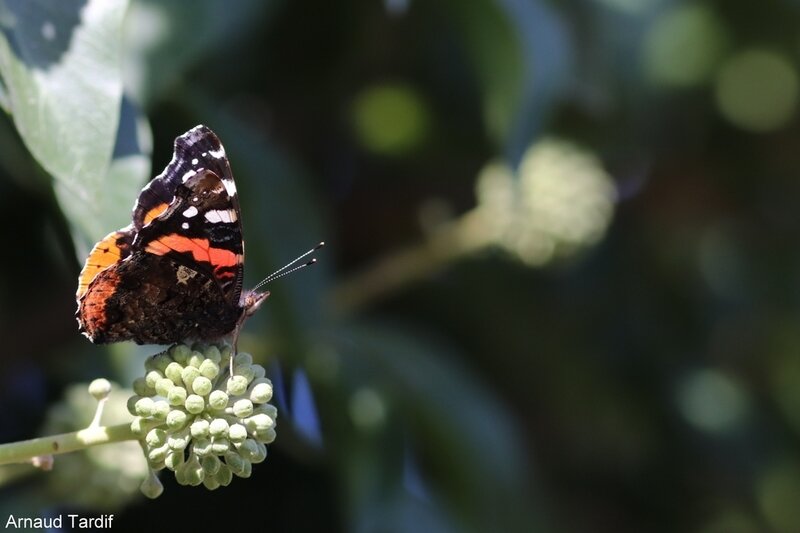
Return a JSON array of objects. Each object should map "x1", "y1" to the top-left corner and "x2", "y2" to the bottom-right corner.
[{"x1": 76, "y1": 126, "x2": 323, "y2": 344}]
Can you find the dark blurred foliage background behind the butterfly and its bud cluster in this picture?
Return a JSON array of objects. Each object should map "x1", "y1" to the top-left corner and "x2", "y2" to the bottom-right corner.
[{"x1": 0, "y1": 0, "x2": 800, "y2": 533}]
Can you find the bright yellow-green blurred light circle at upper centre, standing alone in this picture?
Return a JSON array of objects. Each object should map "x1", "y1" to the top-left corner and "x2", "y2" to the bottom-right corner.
[{"x1": 352, "y1": 84, "x2": 430, "y2": 155}]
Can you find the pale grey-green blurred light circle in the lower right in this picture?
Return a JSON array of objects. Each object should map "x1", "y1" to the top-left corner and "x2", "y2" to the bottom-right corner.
[{"x1": 678, "y1": 370, "x2": 749, "y2": 433}]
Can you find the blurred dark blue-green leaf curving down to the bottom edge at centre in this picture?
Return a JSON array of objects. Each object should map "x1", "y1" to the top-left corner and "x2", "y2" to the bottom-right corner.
[{"x1": 322, "y1": 324, "x2": 534, "y2": 531}]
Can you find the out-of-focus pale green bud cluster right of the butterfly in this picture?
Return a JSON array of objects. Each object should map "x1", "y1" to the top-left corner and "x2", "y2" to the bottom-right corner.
[{"x1": 476, "y1": 138, "x2": 617, "y2": 266}]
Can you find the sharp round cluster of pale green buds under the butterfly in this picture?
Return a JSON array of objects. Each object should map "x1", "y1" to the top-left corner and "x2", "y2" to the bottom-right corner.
[{"x1": 128, "y1": 344, "x2": 278, "y2": 490}]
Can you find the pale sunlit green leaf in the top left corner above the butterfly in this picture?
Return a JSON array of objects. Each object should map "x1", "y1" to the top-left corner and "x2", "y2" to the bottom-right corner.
[{"x1": 0, "y1": 0, "x2": 141, "y2": 248}]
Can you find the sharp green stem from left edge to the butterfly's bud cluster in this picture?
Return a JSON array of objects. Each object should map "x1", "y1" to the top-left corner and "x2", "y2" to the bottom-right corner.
[{"x1": 0, "y1": 423, "x2": 139, "y2": 465}]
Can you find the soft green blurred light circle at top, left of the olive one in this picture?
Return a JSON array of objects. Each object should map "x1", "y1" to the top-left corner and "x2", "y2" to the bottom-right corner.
[{"x1": 643, "y1": 4, "x2": 727, "y2": 87}]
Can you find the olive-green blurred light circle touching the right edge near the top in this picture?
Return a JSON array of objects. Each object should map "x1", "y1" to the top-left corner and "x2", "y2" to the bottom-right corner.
[{"x1": 716, "y1": 49, "x2": 798, "y2": 132}]
